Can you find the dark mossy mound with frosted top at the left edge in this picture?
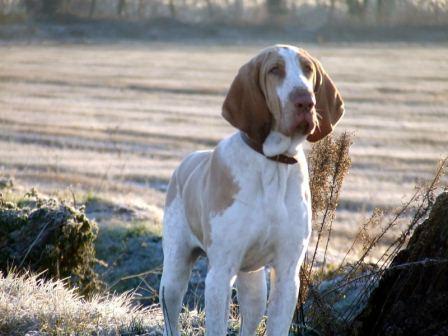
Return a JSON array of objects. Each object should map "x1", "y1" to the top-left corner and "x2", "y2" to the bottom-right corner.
[{"x1": 0, "y1": 190, "x2": 101, "y2": 295}]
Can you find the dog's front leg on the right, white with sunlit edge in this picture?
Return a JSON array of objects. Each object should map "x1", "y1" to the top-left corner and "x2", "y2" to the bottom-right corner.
[{"x1": 267, "y1": 265, "x2": 300, "y2": 336}]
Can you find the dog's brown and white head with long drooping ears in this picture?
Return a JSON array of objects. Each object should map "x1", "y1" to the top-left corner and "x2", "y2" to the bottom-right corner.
[{"x1": 222, "y1": 45, "x2": 344, "y2": 155}]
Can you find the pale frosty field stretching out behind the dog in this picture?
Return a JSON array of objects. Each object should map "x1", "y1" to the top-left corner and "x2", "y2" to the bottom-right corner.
[{"x1": 0, "y1": 43, "x2": 448, "y2": 259}]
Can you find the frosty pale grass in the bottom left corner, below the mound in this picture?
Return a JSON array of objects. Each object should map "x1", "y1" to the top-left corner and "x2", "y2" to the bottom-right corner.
[{"x1": 0, "y1": 272, "x2": 163, "y2": 336}]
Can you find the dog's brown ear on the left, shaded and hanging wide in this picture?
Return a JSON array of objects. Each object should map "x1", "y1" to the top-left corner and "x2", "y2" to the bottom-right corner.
[{"x1": 222, "y1": 57, "x2": 272, "y2": 144}]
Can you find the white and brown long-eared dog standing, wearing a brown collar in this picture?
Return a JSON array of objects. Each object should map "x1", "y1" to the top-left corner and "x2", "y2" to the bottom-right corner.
[{"x1": 160, "y1": 45, "x2": 344, "y2": 336}]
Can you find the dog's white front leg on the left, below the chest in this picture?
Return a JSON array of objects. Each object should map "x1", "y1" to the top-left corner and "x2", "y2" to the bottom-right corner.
[{"x1": 205, "y1": 266, "x2": 234, "y2": 336}]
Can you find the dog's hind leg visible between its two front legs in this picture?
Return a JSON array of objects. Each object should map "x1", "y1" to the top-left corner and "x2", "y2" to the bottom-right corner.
[{"x1": 236, "y1": 268, "x2": 267, "y2": 336}]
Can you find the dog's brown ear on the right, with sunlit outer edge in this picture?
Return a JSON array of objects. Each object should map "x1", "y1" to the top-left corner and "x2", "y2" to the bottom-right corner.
[{"x1": 307, "y1": 56, "x2": 344, "y2": 142}]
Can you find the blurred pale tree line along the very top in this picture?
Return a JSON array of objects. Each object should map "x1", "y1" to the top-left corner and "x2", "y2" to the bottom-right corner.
[{"x1": 0, "y1": 0, "x2": 448, "y2": 24}]
